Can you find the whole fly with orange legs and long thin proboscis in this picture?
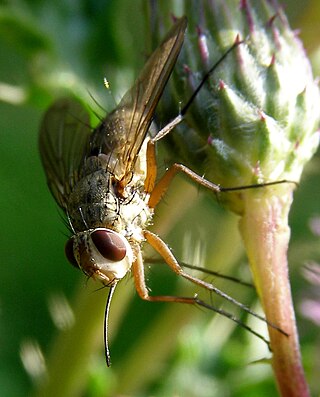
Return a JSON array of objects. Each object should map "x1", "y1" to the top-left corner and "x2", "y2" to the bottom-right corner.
[{"x1": 39, "y1": 17, "x2": 288, "y2": 366}]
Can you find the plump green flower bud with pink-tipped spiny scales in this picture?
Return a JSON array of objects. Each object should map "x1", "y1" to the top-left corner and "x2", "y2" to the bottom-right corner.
[{"x1": 154, "y1": 0, "x2": 320, "y2": 204}]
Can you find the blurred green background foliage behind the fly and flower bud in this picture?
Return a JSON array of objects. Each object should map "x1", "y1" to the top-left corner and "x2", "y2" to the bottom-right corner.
[{"x1": 0, "y1": 0, "x2": 320, "y2": 397}]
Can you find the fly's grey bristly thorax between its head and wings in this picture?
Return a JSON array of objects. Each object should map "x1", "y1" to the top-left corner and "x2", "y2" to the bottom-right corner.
[{"x1": 67, "y1": 146, "x2": 152, "y2": 235}]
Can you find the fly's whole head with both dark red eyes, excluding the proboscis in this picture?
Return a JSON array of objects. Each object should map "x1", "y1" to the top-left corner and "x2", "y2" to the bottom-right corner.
[{"x1": 65, "y1": 228, "x2": 135, "y2": 285}]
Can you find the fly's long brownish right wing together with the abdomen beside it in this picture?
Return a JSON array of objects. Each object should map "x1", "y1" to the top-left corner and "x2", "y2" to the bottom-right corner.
[{"x1": 90, "y1": 17, "x2": 187, "y2": 179}]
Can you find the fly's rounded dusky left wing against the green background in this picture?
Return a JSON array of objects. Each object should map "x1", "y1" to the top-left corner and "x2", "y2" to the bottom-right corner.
[{"x1": 39, "y1": 99, "x2": 92, "y2": 209}]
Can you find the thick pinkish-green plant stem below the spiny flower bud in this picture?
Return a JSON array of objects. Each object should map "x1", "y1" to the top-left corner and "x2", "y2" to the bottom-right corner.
[{"x1": 240, "y1": 184, "x2": 309, "y2": 397}]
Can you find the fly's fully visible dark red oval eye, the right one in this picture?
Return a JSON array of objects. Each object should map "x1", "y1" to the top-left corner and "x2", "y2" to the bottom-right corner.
[{"x1": 91, "y1": 230, "x2": 127, "y2": 262}]
